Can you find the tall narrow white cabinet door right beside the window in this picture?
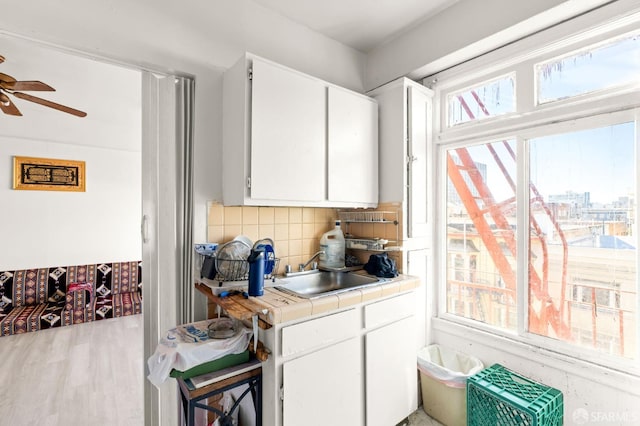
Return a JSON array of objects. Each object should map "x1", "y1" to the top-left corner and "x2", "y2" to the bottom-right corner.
[{"x1": 407, "y1": 86, "x2": 431, "y2": 238}]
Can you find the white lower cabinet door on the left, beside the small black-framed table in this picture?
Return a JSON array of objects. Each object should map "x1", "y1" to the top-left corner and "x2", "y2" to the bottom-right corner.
[{"x1": 282, "y1": 337, "x2": 362, "y2": 426}]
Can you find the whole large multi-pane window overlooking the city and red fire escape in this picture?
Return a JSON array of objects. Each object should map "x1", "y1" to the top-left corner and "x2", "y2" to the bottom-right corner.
[{"x1": 434, "y1": 21, "x2": 640, "y2": 364}]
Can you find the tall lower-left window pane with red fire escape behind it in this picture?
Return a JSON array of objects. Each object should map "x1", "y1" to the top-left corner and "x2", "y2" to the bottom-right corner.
[{"x1": 446, "y1": 140, "x2": 516, "y2": 329}]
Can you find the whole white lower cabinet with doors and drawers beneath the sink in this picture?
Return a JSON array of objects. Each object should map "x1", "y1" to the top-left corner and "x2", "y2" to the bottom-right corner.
[{"x1": 263, "y1": 291, "x2": 418, "y2": 426}]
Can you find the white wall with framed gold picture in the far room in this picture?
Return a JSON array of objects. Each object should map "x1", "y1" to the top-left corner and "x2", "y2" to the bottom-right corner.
[{"x1": 0, "y1": 36, "x2": 141, "y2": 270}]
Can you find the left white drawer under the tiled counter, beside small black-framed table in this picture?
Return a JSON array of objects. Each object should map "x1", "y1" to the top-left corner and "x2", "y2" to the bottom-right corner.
[{"x1": 282, "y1": 309, "x2": 358, "y2": 356}]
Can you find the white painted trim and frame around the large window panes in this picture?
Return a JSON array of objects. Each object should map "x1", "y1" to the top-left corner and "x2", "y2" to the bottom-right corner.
[{"x1": 425, "y1": 1, "x2": 640, "y2": 384}]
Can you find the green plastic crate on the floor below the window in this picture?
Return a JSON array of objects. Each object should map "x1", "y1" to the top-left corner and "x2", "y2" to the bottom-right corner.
[{"x1": 467, "y1": 364, "x2": 564, "y2": 426}]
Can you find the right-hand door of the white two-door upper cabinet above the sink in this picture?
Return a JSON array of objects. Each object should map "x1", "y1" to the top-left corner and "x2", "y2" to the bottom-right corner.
[{"x1": 327, "y1": 87, "x2": 378, "y2": 204}]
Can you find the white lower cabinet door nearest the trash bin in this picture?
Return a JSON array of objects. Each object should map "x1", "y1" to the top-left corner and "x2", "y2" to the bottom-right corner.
[{"x1": 365, "y1": 316, "x2": 418, "y2": 426}]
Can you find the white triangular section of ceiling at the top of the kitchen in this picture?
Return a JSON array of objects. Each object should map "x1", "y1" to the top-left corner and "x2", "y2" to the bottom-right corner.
[{"x1": 254, "y1": 0, "x2": 458, "y2": 53}]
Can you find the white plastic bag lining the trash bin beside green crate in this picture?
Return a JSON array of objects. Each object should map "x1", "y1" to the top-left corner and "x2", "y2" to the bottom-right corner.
[{"x1": 418, "y1": 345, "x2": 484, "y2": 388}]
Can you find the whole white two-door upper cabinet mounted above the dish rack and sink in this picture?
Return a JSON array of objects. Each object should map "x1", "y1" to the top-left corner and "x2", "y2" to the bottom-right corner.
[{"x1": 222, "y1": 54, "x2": 378, "y2": 207}]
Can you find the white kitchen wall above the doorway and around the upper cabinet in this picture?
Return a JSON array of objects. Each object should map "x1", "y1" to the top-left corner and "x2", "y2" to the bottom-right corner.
[{"x1": 0, "y1": 0, "x2": 364, "y2": 250}]
